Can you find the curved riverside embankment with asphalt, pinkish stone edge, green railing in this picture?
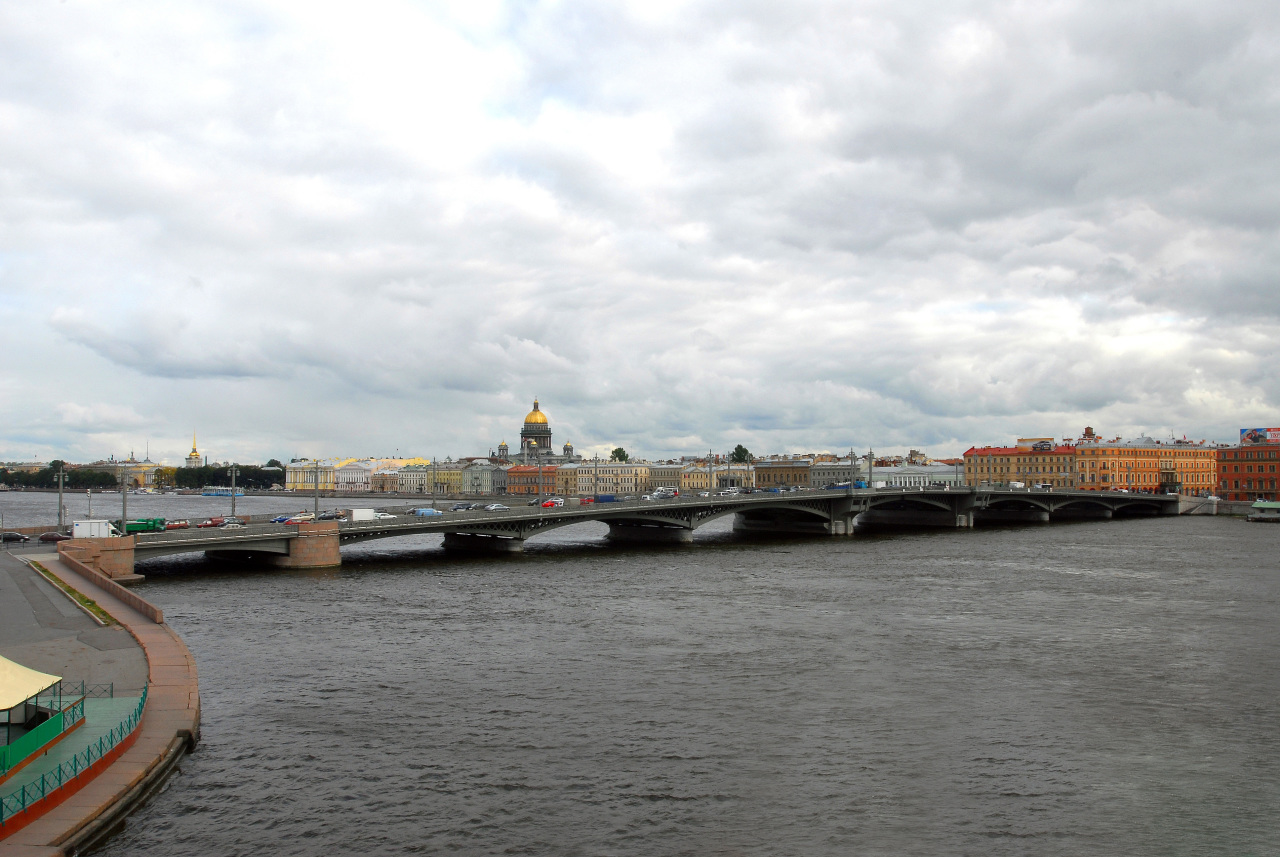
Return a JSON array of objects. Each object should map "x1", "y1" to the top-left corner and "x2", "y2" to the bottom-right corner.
[{"x1": 0, "y1": 553, "x2": 200, "y2": 857}]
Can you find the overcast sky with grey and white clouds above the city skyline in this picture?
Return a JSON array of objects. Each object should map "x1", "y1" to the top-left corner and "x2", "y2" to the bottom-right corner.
[{"x1": 0, "y1": 0, "x2": 1280, "y2": 462}]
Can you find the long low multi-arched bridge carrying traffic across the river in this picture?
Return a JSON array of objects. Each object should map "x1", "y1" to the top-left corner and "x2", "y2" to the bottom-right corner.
[{"x1": 59, "y1": 489, "x2": 1204, "y2": 578}]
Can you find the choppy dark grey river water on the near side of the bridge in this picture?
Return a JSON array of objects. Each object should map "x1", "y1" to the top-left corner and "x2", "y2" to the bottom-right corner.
[{"x1": 87, "y1": 518, "x2": 1280, "y2": 856}]
